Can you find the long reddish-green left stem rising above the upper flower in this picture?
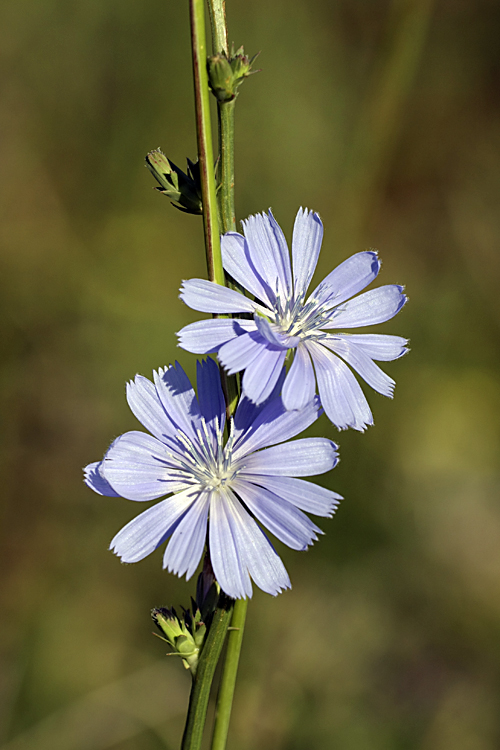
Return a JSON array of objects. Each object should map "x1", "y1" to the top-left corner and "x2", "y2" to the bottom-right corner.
[{"x1": 189, "y1": 0, "x2": 224, "y2": 285}]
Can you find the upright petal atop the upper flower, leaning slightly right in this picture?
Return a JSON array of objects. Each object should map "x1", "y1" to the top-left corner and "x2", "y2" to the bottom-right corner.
[{"x1": 292, "y1": 208, "x2": 323, "y2": 299}]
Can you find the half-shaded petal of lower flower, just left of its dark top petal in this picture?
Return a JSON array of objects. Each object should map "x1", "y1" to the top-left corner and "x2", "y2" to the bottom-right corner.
[{"x1": 153, "y1": 362, "x2": 201, "y2": 439}]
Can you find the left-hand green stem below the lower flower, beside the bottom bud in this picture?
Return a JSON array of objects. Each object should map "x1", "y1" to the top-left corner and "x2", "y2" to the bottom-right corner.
[{"x1": 181, "y1": 594, "x2": 233, "y2": 750}]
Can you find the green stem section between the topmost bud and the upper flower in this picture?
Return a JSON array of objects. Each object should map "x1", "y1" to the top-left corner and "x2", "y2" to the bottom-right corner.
[{"x1": 218, "y1": 99, "x2": 236, "y2": 232}]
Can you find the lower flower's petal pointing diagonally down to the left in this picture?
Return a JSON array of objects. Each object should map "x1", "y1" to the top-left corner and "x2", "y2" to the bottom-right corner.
[{"x1": 109, "y1": 492, "x2": 195, "y2": 563}]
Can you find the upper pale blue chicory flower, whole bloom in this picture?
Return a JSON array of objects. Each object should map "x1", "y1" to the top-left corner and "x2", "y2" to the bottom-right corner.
[{"x1": 179, "y1": 209, "x2": 408, "y2": 430}]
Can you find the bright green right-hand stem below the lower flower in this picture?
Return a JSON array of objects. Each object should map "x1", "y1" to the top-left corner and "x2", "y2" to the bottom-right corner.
[{"x1": 212, "y1": 599, "x2": 248, "y2": 750}]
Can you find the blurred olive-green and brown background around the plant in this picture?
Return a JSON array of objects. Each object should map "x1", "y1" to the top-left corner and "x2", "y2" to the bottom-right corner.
[{"x1": 0, "y1": 0, "x2": 500, "y2": 750}]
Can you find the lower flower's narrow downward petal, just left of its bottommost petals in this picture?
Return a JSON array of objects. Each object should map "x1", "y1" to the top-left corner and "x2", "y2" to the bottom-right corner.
[{"x1": 163, "y1": 492, "x2": 210, "y2": 580}]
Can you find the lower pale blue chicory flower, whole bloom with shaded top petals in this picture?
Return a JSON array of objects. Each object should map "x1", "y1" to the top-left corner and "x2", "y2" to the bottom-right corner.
[{"x1": 85, "y1": 359, "x2": 341, "y2": 598}]
